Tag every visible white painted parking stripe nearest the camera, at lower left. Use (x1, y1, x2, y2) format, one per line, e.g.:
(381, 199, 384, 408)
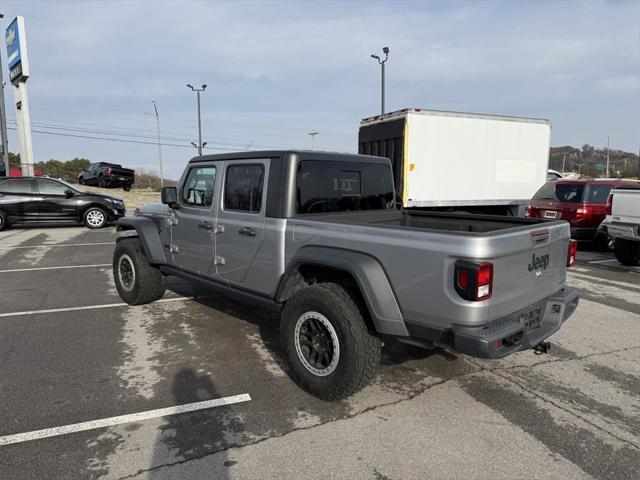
(0, 393, 251, 446)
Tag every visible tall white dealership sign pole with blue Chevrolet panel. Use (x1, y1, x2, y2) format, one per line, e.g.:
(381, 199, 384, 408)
(5, 16, 34, 175)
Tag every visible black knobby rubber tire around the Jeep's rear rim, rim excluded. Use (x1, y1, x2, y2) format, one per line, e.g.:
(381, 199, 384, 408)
(280, 283, 382, 401)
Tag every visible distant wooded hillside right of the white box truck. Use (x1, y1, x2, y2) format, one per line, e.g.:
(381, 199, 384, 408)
(549, 145, 640, 178)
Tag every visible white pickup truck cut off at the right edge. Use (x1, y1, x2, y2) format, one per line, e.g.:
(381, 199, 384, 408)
(603, 184, 640, 266)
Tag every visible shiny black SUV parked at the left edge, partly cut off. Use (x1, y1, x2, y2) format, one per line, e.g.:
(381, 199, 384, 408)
(0, 177, 125, 230)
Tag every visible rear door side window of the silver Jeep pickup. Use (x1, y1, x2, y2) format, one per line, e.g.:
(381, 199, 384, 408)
(224, 165, 264, 213)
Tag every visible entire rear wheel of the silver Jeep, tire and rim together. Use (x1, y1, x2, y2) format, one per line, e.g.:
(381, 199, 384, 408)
(280, 283, 381, 401)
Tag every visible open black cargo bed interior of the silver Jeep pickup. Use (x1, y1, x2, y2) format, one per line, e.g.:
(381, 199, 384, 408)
(299, 210, 550, 235)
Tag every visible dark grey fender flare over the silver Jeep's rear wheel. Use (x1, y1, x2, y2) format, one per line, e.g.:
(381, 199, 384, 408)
(276, 246, 409, 336)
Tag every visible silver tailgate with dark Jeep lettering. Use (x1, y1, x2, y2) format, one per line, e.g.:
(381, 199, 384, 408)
(489, 222, 570, 319)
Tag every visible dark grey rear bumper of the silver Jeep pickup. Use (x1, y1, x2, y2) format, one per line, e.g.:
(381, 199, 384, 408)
(407, 287, 580, 358)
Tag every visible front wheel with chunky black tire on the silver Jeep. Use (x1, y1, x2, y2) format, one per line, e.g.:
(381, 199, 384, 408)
(113, 237, 165, 305)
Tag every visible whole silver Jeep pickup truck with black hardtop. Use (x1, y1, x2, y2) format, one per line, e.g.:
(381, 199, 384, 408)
(113, 151, 579, 400)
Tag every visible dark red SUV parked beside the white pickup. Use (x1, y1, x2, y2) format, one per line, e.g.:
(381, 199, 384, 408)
(527, 179, 631, 248)
